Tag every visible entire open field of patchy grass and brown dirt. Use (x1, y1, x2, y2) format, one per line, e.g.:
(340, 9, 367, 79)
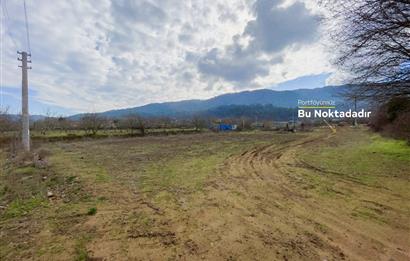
(0, 128, 410, 260)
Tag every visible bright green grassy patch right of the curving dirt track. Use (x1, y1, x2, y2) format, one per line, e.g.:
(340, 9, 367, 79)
(304, 127, 410, 179)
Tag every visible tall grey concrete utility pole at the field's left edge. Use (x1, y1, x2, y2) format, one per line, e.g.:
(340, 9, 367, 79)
(17, 52, 31, 151)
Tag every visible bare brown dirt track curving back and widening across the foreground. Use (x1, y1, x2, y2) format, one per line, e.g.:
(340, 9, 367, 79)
(72, 134, 410, 260)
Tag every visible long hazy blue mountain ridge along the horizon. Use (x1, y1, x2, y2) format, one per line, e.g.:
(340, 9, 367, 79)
(70, 86, 345, 119)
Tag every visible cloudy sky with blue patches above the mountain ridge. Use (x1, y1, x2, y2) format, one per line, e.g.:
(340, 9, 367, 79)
(0, 0, 338, 115)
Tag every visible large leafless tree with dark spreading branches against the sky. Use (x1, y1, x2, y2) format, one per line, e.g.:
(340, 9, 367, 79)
(321, 0, 410, 101)
